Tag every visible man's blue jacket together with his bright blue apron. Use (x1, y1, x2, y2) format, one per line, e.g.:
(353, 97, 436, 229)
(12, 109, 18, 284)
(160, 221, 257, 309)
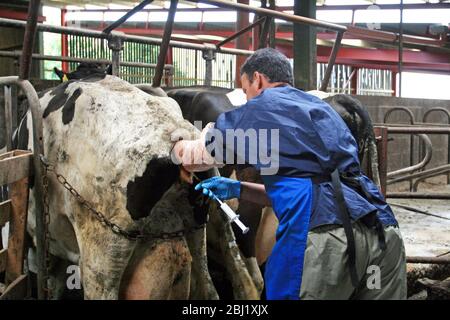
(207, 86, 397, 299)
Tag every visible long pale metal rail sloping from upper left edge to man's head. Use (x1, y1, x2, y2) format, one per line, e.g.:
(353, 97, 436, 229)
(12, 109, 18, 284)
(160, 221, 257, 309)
(0, 18, 253, 55)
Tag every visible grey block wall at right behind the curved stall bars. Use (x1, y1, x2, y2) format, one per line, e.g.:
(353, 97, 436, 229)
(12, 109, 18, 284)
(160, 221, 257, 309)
(356, 96, 450, 182)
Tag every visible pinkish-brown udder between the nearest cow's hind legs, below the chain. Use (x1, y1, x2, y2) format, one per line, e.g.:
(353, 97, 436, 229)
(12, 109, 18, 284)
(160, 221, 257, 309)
(120, 239, 191, 300)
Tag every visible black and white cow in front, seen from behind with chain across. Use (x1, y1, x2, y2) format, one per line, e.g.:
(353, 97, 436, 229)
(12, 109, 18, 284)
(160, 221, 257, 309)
(8, 74, 268, 299)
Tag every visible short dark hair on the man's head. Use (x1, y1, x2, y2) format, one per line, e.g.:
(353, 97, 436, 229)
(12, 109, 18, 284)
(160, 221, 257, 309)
(241, 48, 294, 85)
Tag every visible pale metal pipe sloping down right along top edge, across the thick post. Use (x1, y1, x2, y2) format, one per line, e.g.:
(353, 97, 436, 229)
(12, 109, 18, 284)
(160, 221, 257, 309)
(189, 0, 347, 31)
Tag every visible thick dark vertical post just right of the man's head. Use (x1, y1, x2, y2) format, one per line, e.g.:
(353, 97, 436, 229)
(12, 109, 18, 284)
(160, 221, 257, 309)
(293, 0, 317, 90)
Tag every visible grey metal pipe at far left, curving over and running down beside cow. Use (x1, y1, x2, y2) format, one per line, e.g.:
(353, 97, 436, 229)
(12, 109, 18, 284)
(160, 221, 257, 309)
(0, 76, 48, 300)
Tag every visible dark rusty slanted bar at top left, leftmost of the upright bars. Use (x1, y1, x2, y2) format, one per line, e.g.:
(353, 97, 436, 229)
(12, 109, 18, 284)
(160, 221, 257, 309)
(19, 0, 41, 79)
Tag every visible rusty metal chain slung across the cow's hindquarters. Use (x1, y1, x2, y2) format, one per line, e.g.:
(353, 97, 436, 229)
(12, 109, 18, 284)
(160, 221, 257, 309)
(41, 156, 205, 241)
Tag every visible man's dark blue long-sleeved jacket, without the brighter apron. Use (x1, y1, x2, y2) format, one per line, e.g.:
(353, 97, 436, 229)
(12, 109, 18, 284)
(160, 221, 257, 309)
(213, 86, 398, 230)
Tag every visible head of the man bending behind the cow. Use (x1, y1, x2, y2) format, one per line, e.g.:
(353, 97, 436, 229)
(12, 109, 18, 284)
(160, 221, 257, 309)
(241, 48, 294, 100)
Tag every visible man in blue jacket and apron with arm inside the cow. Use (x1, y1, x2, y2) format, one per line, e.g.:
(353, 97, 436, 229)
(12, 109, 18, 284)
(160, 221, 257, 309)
(174, 49, 406, 299)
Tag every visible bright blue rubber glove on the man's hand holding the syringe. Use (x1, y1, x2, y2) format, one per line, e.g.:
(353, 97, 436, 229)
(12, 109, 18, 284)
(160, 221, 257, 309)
(195, 177, 241, 200)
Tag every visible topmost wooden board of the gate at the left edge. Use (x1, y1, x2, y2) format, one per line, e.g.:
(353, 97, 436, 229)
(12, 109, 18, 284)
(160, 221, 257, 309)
(0, 150, 33, 185)
